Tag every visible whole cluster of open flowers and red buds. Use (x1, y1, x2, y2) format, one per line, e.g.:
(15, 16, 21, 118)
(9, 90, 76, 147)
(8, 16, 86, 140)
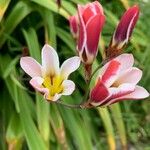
(20, 1, 149, 107)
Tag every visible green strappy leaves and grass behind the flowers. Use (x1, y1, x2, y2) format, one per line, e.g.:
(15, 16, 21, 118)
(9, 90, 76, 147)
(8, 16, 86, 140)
(0, 0, 150, 150)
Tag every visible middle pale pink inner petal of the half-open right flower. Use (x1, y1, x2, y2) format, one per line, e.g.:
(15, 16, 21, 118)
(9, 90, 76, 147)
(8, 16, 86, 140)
(115, 67, 142, 85)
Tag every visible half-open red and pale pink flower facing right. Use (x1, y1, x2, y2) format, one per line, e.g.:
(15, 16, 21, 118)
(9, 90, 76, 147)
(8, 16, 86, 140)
(90, 54, 149, 106)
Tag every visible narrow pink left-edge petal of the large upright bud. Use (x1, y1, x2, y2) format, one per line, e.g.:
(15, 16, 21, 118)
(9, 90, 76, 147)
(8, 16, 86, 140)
(78, 5, 87, 51)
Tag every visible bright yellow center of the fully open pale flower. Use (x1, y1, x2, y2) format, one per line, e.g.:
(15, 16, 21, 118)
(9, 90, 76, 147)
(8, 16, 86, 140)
(43, 76, 63, 100)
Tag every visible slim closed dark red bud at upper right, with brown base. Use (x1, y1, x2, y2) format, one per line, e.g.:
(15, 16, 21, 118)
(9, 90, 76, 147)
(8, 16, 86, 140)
(106, 5, 139, 58)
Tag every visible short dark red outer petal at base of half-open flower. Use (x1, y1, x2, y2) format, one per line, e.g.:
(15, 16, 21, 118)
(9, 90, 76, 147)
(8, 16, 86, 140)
(90, 78, 109, 106)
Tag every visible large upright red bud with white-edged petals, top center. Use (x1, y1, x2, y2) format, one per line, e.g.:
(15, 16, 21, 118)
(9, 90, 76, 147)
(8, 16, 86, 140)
(77, 1, 105, 65)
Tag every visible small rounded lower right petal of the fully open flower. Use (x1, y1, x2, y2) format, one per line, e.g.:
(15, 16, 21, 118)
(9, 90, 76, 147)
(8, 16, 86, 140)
(62, 80, 75, 95)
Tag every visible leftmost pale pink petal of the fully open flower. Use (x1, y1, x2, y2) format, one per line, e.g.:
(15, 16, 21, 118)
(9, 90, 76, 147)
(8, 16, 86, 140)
(20, 57, 42, 77)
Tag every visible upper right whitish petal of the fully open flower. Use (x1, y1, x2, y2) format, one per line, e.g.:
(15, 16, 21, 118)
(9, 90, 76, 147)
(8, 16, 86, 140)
(60, 56, 80, 79)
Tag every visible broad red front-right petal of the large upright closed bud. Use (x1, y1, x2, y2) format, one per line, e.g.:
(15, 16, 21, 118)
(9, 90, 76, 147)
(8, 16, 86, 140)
(86, 14, 105, 55)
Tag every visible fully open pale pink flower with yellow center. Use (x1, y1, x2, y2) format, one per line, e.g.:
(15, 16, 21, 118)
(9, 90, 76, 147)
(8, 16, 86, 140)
(20, 44, 80, 101)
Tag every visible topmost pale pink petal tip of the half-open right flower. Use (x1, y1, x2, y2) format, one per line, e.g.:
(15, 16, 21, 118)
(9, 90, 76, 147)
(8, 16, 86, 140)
(114, 54, 134, 72)
